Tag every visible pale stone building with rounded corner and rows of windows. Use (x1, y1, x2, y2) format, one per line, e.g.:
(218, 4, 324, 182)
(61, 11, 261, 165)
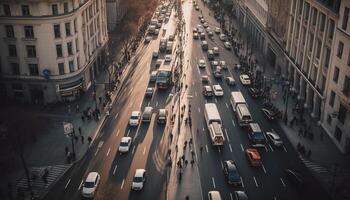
(0, 0, 108, 103)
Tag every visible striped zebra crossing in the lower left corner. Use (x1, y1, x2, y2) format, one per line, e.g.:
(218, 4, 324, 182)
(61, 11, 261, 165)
(16, 164, 71, 197)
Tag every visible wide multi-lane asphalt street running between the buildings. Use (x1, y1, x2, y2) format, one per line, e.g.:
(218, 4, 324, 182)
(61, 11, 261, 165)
(45, 0, 329, 200)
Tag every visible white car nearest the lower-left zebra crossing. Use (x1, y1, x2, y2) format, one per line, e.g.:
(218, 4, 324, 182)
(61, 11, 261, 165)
(81, 172, 101, 198)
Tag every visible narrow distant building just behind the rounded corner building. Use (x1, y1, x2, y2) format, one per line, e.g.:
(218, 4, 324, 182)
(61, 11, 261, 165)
(106, 0, 127, 31)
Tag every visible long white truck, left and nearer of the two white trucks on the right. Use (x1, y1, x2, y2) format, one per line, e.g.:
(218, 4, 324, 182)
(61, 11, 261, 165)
(204, 103, 225, 146)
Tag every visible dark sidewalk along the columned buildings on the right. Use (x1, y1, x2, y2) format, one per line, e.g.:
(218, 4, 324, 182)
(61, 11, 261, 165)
(224, 8, 350, 200)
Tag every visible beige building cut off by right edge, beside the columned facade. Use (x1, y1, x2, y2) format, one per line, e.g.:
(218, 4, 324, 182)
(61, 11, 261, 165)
(322, 1, 350, 153)
